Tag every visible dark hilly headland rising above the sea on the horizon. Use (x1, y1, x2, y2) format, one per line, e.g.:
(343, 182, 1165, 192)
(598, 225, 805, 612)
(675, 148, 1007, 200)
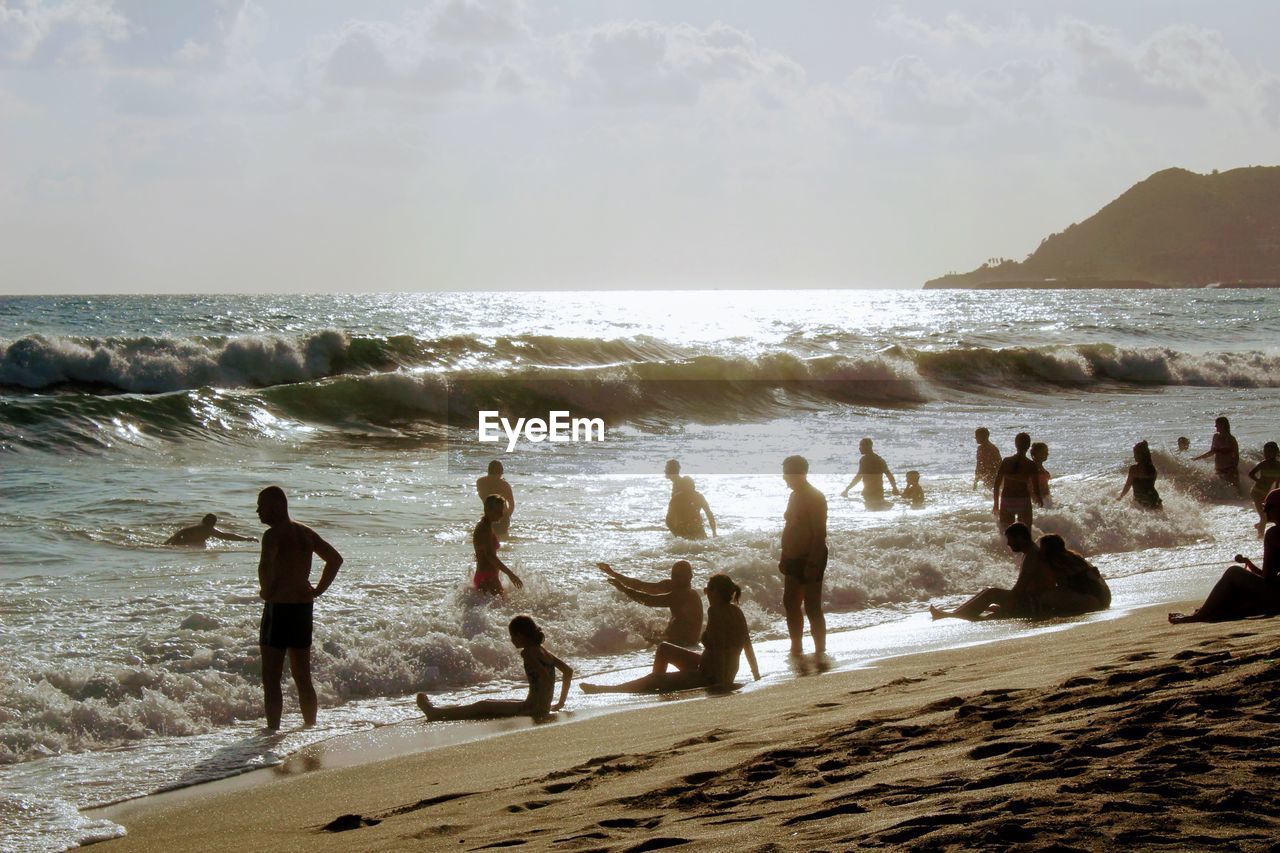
(924, 167, 1280, 289)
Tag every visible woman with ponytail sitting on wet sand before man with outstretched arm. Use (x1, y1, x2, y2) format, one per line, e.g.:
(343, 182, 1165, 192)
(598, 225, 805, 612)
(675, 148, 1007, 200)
(581, 574, 760, 693)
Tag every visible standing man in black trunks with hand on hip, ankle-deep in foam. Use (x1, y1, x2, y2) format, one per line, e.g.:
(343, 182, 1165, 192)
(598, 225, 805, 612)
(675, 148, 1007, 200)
(257, 485, 342, 731)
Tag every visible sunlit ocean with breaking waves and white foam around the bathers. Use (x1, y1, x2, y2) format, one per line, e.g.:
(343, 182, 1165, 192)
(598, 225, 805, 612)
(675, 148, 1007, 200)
(0, 289, 1280, 850)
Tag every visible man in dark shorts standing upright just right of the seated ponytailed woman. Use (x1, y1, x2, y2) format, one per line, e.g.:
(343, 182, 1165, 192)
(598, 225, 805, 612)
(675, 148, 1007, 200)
(778, 456, 827, 656)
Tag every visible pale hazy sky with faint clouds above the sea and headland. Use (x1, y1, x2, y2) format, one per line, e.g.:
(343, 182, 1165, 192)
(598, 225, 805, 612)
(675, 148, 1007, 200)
(0, 0, 1280, 295)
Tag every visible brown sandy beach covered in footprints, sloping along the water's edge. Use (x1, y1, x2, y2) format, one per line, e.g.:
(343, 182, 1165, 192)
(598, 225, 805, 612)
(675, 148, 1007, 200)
(102, 606, 1280, 852)
